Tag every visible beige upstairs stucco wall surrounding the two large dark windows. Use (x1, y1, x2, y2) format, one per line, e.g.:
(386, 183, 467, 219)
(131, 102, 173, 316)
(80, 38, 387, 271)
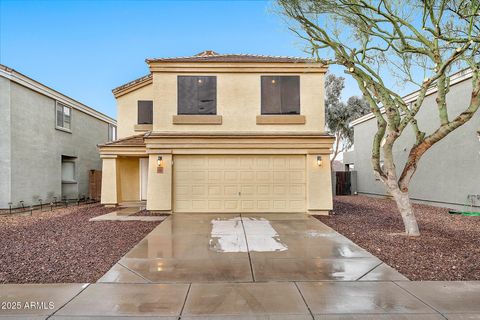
(153, 72, 325, 131)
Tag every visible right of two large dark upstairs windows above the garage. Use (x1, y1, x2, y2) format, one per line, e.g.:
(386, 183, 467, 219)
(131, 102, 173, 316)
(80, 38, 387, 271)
(262, 76, 300, 114)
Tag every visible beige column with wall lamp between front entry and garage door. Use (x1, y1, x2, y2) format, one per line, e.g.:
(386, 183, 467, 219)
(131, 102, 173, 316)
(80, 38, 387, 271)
(147, 153, 172, 211)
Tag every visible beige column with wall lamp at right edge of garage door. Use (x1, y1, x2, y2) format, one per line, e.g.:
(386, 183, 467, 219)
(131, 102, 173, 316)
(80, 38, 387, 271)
(307, 154, 333, 214)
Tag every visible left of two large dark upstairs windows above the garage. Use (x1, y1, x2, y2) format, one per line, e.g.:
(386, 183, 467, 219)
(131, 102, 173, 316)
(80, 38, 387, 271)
(177, 76, 217, 114)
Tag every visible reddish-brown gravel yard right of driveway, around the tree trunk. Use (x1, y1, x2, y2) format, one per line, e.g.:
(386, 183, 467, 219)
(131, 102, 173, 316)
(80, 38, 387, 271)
(317, 196, 480, 280)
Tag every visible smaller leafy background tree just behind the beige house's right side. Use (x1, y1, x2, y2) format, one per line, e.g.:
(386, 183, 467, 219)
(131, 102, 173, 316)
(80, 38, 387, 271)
(325, 74, 370, 165)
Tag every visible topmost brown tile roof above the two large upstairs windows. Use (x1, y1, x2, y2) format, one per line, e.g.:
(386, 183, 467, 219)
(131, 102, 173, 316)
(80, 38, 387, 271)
(146, 50, 317, 63)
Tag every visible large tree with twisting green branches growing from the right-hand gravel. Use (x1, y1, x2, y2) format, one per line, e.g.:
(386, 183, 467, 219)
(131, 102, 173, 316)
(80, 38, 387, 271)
(278, 0, 480, 236)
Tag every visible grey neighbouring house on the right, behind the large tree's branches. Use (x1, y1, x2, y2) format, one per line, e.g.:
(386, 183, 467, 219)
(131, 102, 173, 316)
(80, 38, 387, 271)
(343, 70, 480, 209)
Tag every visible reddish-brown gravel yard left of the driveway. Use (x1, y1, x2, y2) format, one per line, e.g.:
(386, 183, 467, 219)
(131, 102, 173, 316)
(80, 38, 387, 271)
(0, 204, 159, 283)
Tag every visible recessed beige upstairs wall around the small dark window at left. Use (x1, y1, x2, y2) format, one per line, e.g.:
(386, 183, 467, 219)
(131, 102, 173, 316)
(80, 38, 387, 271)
(117, 84, 153, 139)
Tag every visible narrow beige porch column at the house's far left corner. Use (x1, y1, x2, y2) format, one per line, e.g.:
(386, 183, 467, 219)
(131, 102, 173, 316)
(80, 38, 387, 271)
(101, 155, 118, 206)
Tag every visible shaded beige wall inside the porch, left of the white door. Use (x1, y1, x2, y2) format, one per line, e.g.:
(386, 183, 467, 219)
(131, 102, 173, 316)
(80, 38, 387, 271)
(117, 157, 140, 202)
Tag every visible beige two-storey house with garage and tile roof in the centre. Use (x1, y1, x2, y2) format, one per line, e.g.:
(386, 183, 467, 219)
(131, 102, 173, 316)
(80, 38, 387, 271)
(100, 51, 333, 213)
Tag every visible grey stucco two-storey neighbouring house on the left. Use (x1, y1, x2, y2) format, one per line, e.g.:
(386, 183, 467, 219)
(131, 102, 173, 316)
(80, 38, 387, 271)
(0, 65, 116, 208)
